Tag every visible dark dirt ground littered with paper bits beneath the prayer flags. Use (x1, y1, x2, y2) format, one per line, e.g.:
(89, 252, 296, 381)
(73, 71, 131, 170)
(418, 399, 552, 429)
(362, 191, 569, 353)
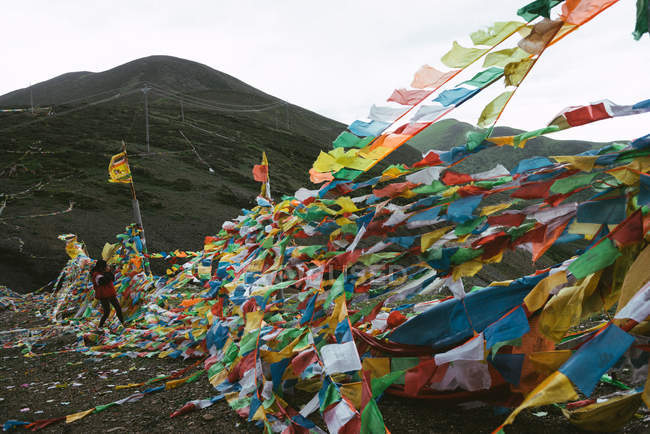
(0, 300, 650, 434)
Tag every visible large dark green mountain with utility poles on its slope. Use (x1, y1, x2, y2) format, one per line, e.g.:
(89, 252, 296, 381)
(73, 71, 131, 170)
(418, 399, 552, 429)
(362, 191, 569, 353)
(0, 56, 419, 290)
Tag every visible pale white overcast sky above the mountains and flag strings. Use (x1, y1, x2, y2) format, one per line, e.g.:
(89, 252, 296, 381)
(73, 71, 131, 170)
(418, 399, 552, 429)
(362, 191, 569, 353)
(0, 0, 650, 141)
